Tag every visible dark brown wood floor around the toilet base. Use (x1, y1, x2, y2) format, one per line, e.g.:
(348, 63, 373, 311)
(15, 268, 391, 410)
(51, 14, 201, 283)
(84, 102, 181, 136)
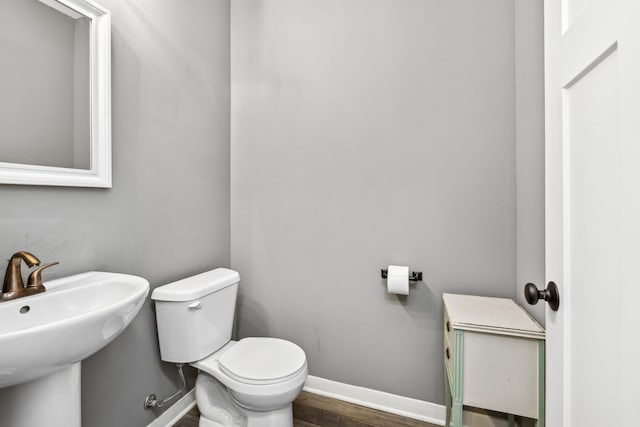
(174, 391, 436, 427)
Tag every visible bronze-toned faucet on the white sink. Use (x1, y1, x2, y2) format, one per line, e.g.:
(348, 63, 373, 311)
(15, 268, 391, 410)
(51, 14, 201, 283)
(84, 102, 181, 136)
(0, 251, 58, 302)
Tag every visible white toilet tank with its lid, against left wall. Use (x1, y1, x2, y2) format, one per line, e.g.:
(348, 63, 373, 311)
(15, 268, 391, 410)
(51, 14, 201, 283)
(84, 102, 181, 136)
(151, 268, 240, 363)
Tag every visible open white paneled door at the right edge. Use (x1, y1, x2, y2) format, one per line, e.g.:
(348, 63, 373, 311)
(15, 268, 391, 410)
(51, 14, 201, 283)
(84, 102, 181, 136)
(545, 0, 640, 427)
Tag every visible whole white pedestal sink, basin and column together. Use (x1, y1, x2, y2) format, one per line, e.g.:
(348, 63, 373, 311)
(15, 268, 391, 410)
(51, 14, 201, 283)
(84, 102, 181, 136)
(0, 272, 149, 427)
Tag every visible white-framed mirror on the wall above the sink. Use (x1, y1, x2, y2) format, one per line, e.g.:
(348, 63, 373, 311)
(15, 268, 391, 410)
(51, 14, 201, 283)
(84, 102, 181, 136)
(0, 0, 111, 187)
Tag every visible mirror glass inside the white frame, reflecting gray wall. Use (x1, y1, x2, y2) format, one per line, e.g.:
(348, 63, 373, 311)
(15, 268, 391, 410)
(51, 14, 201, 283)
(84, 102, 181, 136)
(0, 0, 91, 169)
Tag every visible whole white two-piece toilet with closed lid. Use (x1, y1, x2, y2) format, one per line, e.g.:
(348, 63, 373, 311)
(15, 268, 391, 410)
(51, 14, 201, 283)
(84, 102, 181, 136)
(151, 268, 307, 427)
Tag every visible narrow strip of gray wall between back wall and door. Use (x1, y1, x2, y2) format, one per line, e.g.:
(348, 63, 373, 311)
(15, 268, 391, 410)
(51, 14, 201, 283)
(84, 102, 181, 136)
(514, 0, 546, 325)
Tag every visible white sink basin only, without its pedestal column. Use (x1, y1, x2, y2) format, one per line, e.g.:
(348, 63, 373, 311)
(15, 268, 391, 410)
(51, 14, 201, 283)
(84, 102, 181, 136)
(0, 271, 149, 388)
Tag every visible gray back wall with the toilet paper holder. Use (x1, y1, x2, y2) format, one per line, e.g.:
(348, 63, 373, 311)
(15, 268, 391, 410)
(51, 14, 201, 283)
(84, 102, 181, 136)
(231, 0, 516, 403)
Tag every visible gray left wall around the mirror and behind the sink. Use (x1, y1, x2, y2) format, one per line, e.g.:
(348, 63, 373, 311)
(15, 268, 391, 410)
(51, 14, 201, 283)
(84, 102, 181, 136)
(0, 0, 229, 427)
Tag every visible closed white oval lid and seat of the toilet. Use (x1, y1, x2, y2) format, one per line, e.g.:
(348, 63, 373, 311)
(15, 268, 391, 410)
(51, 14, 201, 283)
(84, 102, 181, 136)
(218, 338, 307, 383)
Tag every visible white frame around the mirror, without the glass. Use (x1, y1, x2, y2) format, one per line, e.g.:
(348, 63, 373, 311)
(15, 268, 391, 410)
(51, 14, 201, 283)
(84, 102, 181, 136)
(0, 0, 111, 188)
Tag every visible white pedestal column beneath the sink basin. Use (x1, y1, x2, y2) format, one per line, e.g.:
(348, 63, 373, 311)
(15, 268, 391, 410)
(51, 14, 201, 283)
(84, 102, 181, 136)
(0, 362, 81, 427)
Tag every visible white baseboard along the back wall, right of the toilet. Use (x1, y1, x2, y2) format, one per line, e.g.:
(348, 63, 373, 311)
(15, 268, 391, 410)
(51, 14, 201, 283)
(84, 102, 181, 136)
(304, 375, 508, 427)
